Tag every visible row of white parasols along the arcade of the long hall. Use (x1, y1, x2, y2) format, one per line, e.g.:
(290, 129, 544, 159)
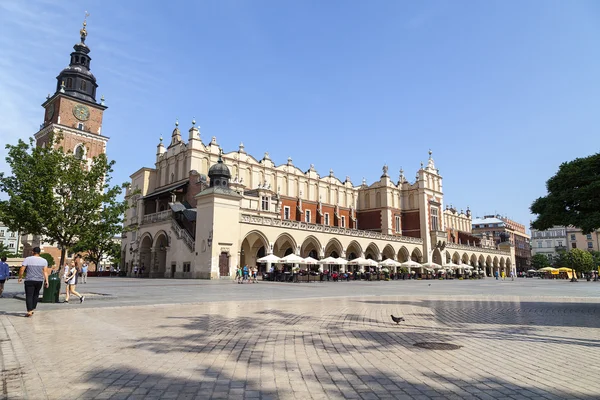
(257, 254, 474, 271)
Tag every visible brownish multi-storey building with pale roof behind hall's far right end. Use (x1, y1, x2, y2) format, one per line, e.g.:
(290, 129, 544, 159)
(473, 215, 531, 272)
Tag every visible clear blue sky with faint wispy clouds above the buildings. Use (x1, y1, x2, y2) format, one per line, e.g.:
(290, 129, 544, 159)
(0, 0, 600, 230)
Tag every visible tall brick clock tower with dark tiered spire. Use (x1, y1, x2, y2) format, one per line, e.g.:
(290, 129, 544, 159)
(34, 16, 108, 159)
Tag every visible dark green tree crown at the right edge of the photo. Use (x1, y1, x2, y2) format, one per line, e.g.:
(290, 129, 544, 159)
(531, 153, 600, 233)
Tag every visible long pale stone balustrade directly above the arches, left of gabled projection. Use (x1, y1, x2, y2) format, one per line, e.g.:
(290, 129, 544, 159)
(240, 214, 423, 244)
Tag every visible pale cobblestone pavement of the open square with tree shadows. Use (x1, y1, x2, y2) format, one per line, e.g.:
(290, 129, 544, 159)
(0, 282, 600, 399)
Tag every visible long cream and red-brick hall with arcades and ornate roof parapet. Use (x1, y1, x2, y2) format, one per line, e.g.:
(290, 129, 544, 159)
(121, 121, 515, 279)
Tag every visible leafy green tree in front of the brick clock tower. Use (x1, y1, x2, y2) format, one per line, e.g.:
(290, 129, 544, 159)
(0, 137, 125, 265)
